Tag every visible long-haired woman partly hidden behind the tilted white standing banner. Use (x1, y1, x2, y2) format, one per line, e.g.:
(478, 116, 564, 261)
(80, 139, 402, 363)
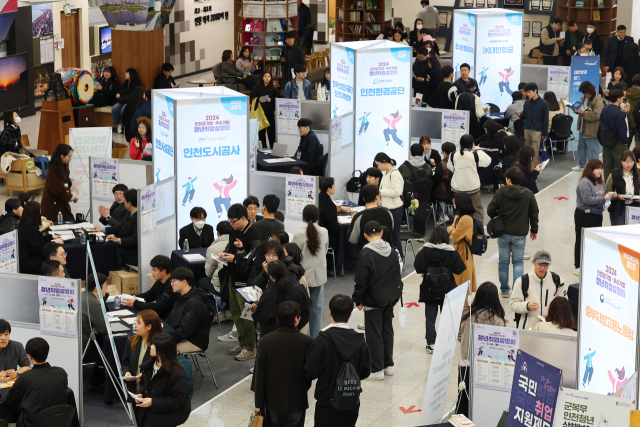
(456, 282, 507, 416)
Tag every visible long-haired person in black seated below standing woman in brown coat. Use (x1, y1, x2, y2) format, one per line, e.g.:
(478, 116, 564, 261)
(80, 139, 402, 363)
(18, 202, 64, 275)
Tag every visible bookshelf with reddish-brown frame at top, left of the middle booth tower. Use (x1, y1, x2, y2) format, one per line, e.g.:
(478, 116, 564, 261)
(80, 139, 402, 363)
(234, 0, 298, 87)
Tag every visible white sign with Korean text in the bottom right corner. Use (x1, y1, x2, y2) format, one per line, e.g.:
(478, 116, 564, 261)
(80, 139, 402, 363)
(553, 387, 635, 427)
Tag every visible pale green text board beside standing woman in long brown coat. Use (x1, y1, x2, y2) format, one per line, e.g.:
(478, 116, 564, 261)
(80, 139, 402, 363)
(69, 127, 113, 221)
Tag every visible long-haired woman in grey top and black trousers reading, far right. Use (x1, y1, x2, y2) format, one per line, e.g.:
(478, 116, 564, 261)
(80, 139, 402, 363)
(573, 159, 617, 276)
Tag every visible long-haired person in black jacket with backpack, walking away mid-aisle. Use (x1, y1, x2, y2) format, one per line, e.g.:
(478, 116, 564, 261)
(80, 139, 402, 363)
(413, 227, 467, 354)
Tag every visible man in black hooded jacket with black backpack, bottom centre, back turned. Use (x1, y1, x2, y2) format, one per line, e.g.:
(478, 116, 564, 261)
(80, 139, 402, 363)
(304, 294, 371, 427)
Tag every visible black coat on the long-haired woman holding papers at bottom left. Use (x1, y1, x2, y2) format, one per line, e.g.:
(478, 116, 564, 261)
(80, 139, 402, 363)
(136, 358, 191, 427)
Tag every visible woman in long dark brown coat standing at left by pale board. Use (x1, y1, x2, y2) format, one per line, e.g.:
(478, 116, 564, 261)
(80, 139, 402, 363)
(42, 144, 78, 221)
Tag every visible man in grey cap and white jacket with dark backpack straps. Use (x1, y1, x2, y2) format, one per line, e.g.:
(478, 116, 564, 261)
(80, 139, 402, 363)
(509, 250, 569, 329)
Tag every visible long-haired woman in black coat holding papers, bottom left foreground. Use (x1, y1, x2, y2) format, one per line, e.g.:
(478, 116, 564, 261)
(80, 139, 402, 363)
(136, 332, 191, 427)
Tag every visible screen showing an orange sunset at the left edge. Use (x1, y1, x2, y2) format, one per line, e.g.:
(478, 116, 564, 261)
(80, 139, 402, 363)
(0, 53, 29, 111)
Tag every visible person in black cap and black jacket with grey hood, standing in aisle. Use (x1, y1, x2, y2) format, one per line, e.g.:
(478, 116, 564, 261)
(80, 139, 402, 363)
(352, 221, 402, 381)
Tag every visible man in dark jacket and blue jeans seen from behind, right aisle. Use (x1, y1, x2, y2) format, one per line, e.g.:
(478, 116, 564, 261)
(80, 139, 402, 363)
(487, 168, 539, 298)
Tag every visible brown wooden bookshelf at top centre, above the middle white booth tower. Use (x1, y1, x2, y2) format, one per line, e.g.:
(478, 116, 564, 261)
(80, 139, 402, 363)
(336, 0, 384, 42)
